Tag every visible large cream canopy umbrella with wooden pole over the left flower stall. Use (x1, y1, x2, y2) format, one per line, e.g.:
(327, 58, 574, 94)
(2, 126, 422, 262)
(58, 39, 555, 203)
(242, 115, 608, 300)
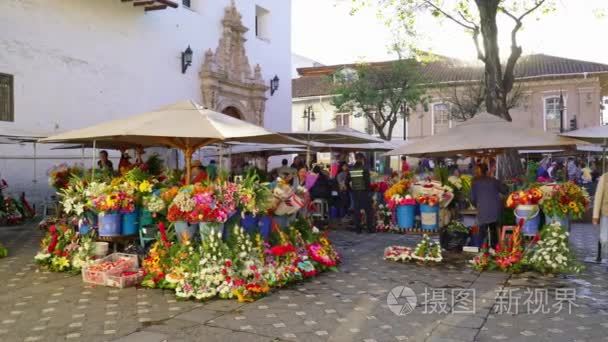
(40, 100, 293, 181)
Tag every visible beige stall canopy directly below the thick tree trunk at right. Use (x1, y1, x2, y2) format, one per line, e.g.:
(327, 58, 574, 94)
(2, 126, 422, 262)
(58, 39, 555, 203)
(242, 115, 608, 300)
(387, 113, 587, 157)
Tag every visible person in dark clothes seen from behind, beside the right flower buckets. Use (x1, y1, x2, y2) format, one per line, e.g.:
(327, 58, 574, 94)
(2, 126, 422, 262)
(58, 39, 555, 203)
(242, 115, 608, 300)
(471, 164, 508, 247)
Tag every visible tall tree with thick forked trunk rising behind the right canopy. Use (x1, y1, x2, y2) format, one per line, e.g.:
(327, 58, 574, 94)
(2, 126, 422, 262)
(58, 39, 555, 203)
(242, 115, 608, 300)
(352, 0, 555, 176)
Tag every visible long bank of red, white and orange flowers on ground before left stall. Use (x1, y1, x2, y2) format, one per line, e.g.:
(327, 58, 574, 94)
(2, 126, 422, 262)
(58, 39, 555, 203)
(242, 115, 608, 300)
(142, 220, 340, 302)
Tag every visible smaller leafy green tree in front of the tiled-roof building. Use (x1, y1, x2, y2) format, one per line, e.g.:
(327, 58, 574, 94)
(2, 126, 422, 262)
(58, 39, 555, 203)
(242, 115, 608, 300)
(331, 60, 424, 140)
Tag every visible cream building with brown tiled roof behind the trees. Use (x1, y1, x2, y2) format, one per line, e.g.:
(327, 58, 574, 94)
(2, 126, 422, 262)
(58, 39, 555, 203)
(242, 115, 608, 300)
(292, 54, 608, 140)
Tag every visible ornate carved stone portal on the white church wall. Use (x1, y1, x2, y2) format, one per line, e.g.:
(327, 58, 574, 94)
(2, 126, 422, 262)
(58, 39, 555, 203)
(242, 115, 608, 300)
(200, 0, 268, 126)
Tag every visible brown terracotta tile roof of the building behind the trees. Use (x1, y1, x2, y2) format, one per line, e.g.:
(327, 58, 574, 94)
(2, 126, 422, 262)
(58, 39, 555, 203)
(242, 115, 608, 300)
(292, 54, 608, 97)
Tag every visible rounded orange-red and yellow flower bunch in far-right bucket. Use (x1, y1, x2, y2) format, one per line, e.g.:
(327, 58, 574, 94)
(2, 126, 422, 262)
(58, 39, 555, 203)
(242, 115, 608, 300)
(540, 182, 589, 219)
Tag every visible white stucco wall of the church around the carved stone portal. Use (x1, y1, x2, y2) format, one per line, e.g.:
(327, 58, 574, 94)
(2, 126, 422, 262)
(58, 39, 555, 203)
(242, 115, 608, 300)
(0, 0, 291, 203)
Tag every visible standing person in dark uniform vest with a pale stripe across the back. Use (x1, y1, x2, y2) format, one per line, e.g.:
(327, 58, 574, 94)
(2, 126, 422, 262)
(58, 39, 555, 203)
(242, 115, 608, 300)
(349, 153, 375, 234)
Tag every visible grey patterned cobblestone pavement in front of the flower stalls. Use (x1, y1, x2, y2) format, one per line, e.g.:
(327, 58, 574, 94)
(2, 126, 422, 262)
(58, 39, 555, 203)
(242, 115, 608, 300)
(0, 225, 608, 342)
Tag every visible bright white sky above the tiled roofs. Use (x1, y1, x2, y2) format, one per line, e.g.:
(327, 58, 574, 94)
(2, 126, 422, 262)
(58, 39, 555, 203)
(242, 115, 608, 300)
(292, 0, 608, 65)
